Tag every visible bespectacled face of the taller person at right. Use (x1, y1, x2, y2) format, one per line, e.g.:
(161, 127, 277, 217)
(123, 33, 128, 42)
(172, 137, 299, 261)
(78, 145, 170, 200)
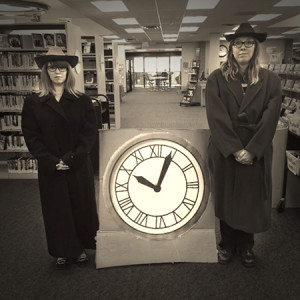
(232, 37, 256, 65)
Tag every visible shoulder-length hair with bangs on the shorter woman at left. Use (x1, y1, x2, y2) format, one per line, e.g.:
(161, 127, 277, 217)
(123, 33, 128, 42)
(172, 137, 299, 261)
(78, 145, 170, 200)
(39, 60, 81, 98)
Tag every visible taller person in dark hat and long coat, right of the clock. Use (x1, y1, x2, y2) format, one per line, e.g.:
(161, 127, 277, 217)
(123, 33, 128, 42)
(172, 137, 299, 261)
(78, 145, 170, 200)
(206, 23, 281, 267)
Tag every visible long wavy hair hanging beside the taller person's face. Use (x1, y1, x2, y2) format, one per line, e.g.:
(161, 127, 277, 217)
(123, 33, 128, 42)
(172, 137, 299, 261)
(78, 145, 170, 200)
(221, 41, 260, 85)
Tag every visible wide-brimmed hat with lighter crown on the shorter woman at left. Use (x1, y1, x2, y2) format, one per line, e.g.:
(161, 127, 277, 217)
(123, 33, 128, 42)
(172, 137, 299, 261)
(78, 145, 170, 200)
(34, 46, 78, 69)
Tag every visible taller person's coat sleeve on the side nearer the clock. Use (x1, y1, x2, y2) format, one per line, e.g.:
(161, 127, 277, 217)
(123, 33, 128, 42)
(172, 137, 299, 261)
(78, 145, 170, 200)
(206, 72, 244, 157)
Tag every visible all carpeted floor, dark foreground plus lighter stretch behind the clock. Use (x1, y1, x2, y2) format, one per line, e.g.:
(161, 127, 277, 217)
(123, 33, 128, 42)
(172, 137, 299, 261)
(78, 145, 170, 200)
(0, 90, 300, 300)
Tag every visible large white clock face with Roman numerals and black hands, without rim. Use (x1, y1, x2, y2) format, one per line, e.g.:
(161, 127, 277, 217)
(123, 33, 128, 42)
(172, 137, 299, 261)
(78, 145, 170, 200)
(109, 138, 205, 235)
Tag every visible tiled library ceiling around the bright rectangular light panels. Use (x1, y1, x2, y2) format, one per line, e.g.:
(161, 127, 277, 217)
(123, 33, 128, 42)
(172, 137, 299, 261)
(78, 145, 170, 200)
(0, 0, 300, 44)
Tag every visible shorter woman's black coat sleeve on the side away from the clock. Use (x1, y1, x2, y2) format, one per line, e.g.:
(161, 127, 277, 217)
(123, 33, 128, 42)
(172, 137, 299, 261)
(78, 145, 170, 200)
(21, 97, 59, 172)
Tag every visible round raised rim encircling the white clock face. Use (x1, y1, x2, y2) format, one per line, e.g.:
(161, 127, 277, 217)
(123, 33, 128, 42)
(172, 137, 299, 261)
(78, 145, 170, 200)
(103, 132, 209, 240)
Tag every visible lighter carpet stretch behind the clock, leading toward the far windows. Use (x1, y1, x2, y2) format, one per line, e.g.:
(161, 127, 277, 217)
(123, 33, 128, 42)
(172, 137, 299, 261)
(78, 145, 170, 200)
(121, 88, 208, 129)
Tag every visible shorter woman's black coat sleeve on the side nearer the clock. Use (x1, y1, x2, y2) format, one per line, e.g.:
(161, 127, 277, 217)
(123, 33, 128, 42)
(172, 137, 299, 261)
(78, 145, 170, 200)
(62, 95, 97, 168)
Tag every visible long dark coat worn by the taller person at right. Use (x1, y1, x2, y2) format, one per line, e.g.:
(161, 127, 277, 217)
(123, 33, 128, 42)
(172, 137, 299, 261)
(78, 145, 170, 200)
(206, 69, 282, 233)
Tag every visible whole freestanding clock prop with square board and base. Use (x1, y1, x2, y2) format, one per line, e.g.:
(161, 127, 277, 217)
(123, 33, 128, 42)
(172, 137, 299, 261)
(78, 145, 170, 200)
(96, 129, 217, 268)
